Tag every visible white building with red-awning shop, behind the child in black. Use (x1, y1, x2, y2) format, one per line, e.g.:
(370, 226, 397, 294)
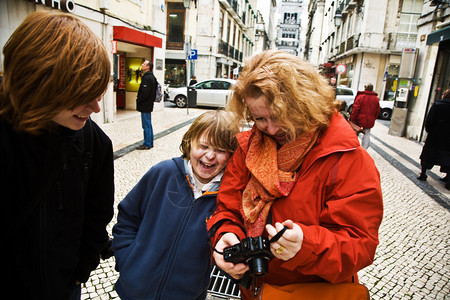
(0, 0, 165, 123)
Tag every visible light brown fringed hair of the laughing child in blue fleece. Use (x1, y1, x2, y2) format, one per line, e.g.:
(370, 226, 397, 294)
(180, 109, 239, 159)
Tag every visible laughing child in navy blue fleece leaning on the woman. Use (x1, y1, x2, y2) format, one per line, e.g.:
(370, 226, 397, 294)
(113, 110, 239, 300)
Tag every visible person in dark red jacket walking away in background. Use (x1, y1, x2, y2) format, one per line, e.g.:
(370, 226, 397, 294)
(350, 83, 381, 150)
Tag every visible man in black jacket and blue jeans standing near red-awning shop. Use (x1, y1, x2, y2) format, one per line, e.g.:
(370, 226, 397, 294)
(136, 60, 156, 150)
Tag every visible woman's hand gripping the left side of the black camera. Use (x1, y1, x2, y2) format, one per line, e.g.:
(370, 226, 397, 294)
(213, 232, 249, 280)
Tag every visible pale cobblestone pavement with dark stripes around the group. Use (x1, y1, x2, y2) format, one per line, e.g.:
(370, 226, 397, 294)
(81, 107, 450, 299)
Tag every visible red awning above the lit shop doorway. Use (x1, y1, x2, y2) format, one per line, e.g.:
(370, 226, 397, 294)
(113, 26, 162, 48)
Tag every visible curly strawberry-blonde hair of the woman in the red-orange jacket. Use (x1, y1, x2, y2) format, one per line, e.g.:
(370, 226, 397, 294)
(228, 50, 335, 140)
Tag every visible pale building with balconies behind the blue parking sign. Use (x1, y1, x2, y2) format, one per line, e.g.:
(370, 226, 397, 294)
(165, 0, 264, 87)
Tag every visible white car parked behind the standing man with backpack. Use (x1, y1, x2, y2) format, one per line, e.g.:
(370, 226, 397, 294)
(167, 78, 236, 107)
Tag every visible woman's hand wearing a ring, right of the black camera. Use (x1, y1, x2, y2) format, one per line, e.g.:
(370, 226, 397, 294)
(266, 220, 303, 261)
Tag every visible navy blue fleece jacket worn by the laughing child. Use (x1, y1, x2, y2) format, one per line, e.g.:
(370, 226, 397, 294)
(112, 157, 219, 300)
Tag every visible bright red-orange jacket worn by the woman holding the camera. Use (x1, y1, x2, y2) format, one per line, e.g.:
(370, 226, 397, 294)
(208, 113, 383, 285)
